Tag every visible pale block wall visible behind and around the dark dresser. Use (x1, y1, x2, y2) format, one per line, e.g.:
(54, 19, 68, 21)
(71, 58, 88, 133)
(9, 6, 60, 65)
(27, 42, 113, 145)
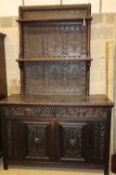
(0, 0, 116, 170)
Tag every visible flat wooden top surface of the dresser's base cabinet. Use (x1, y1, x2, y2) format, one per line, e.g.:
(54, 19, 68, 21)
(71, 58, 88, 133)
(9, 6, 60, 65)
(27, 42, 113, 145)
(0, 94, 113, 107)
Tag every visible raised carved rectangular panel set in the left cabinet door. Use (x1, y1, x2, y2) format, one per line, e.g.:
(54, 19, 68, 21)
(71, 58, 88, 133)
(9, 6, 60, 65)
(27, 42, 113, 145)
(24, 122, 52, 161)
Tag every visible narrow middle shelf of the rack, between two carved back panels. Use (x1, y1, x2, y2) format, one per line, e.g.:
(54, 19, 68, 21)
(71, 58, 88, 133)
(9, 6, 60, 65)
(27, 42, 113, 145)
(16, 56, 92, 62)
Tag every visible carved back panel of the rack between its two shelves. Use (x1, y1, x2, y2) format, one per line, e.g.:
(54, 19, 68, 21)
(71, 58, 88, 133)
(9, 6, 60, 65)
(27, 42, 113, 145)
(23, 21, 87, 59)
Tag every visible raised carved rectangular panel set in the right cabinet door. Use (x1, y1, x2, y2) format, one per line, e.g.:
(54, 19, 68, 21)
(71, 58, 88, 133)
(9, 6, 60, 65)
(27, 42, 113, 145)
(57, 122, 89, 161)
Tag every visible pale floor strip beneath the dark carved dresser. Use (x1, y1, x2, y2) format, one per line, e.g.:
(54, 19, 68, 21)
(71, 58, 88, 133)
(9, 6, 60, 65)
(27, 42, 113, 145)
(0, 160, 115, 175)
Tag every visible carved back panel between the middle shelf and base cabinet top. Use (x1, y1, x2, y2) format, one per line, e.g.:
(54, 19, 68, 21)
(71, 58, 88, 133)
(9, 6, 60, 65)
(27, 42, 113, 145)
(25, 61, 86, 95)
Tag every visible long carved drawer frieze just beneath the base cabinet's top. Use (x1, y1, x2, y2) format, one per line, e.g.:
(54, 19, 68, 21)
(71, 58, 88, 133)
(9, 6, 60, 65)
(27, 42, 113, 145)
(3, 106, 107, 119)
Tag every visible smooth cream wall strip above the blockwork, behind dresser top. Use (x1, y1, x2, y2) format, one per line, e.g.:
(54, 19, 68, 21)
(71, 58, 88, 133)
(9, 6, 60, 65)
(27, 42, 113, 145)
(0, 0, 116, 16)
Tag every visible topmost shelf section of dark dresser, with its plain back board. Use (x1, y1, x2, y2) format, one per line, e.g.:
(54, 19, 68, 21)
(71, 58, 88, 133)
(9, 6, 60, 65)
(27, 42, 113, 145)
(17, 3, 92, 22)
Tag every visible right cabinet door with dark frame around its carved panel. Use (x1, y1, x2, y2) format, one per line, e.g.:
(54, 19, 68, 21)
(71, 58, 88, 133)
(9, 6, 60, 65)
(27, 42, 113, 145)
(56, 122, 90, 162)
